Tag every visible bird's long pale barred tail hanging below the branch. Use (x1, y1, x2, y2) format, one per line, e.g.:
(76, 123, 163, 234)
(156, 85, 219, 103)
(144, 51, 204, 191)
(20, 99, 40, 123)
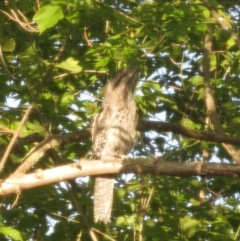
(93, 176, 114, 223)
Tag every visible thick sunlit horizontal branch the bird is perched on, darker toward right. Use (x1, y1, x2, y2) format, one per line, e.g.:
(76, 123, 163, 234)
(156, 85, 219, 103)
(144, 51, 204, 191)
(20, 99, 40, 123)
(0, 158, 240, 195)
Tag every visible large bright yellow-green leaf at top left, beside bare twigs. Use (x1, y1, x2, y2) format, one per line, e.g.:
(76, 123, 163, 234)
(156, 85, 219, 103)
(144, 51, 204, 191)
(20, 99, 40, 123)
(33, 5, 64, 33)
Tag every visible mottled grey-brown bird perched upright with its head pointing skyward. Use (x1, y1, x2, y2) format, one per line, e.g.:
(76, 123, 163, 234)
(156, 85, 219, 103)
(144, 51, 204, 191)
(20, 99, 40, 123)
(92, 67, 138, 223)
